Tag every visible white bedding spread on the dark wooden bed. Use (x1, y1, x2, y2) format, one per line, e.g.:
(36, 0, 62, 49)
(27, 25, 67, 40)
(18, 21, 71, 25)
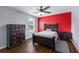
(35, 31, 58, 41)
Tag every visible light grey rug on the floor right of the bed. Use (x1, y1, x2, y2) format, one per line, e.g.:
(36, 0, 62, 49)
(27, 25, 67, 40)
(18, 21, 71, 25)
(55, 40, 70, 53)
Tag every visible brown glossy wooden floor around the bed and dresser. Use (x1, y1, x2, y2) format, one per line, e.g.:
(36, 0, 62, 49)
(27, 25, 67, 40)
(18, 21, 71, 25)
(0, 39, 78, 53)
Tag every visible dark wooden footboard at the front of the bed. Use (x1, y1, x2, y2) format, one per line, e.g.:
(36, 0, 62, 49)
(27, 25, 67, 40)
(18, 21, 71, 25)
(33, 34, 55, 50)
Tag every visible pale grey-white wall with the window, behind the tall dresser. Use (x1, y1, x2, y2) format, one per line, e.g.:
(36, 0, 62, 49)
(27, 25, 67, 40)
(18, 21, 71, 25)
(0, 7, 37, 48)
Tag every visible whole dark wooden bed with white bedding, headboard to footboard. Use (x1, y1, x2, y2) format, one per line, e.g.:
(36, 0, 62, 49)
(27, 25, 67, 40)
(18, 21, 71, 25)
(33, 24, 58, 50)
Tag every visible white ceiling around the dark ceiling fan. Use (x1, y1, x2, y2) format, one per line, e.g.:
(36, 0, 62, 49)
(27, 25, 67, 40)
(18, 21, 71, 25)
(10, 6, 71, 17)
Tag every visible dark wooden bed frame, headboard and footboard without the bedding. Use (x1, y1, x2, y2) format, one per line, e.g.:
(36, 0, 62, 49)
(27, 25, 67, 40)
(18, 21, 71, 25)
(33, 24, 58, 50)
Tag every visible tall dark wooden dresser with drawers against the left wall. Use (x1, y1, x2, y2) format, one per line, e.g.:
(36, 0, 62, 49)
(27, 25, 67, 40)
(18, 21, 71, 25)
(7, 24, 25, 48)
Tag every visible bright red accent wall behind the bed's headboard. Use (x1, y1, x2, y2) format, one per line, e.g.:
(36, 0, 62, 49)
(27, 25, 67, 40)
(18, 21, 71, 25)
(38, 12, 71, 32)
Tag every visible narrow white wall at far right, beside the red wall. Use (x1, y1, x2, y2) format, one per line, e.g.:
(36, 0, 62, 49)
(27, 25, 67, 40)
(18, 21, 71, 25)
(72, 7, 79, 52)
